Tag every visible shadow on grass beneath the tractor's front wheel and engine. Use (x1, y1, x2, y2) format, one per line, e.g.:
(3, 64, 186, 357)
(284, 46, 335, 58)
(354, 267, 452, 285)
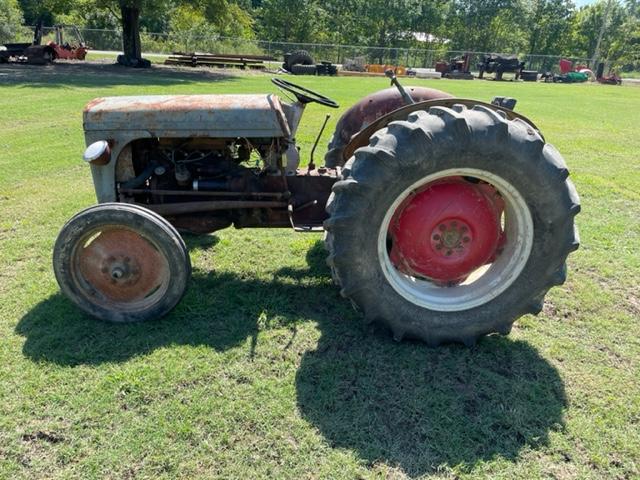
(16, 235, 330, 366)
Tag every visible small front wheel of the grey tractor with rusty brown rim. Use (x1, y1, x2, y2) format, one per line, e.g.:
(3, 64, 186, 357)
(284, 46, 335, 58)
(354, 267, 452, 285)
(53, 203, 191, 322)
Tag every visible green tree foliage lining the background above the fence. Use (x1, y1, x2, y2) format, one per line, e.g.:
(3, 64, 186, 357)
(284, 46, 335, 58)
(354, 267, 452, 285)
(7, 0, 640, 68)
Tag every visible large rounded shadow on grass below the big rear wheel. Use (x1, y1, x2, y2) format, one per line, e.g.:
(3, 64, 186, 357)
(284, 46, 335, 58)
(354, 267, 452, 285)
(297, 331, 566, 477)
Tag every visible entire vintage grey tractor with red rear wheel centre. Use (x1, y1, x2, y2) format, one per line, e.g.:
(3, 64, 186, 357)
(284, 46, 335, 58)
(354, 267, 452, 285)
(53, 74, 580, 345)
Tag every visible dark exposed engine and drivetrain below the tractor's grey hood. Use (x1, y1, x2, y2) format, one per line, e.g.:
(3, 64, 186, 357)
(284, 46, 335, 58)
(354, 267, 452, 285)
(116, 138, 337, 233)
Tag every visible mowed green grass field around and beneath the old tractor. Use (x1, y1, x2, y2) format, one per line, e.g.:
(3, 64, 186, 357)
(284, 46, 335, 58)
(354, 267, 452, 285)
(0, 64, 640, 479)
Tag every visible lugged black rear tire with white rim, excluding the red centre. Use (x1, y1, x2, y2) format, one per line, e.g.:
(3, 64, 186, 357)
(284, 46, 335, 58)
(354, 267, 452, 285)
(325, 105, 580, 346)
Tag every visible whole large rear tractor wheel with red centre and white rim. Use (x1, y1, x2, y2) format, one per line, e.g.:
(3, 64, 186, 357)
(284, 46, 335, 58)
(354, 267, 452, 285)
(325, 105, 580, 346)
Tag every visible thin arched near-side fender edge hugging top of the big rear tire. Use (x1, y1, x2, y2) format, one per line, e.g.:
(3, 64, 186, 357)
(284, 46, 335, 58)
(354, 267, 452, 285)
(340, 97, 544, 161)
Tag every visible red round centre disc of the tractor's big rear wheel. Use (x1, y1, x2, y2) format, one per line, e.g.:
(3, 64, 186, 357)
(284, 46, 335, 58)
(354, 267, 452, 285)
(389, 177, 502, 284)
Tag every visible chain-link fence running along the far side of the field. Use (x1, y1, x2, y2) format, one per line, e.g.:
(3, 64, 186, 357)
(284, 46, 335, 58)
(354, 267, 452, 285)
(10, 27, 595, 72)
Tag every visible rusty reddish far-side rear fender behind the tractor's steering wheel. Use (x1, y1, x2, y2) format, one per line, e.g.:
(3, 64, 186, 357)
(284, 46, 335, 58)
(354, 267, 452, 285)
(324, 87, 452, 167)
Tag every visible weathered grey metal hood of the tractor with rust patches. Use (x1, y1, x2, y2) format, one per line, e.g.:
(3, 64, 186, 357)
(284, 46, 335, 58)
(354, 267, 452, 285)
(83, 95, 290, 138)
